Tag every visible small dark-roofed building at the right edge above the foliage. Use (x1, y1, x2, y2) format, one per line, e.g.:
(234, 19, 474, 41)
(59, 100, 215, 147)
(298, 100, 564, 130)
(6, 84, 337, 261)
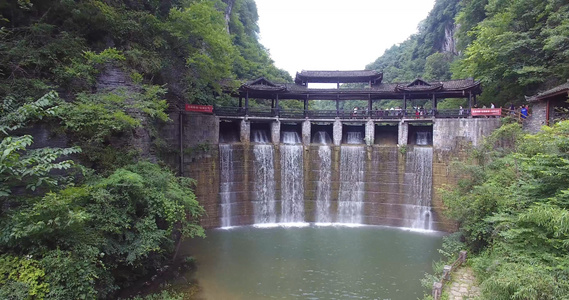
(524, 80, 569, 133)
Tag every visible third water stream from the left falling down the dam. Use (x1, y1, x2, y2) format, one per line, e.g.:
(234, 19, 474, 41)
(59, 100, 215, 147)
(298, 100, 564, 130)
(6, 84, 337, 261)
(280, 132, 304, 223)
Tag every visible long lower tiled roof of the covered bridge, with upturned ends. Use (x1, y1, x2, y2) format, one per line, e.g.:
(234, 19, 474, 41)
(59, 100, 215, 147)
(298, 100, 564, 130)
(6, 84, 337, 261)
(239, 78, 482, 100)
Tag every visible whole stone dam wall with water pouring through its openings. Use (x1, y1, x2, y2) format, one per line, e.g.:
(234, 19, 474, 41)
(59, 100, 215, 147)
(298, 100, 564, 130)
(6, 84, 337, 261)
(162, 112, 500, 231)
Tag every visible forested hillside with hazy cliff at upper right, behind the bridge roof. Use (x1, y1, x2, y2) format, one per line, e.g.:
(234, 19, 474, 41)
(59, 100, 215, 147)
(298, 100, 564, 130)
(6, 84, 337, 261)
(366, 0, 569, 105)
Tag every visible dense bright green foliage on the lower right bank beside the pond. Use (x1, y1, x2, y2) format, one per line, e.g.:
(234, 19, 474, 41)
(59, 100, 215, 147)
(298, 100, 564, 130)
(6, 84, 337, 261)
(443, 121, 569, 300)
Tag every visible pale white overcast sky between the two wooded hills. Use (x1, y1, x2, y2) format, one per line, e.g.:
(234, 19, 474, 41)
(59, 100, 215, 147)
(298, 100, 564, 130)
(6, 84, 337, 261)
(256, 0, 435, 78)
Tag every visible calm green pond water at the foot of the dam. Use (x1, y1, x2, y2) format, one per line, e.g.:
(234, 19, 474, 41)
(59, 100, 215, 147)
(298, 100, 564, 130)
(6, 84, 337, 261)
(184, 225, 443, 300)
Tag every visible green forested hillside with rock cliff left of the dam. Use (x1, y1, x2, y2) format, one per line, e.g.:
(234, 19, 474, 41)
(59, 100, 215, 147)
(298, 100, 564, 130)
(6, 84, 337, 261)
(0, 0, 291, 299)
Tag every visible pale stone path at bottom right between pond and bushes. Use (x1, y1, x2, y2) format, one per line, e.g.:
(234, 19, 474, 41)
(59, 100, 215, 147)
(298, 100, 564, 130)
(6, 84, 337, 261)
(445, 266, 480, 300)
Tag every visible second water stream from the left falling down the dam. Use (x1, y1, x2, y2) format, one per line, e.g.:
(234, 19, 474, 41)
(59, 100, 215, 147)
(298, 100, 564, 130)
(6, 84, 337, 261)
(253, 144, 277, 224)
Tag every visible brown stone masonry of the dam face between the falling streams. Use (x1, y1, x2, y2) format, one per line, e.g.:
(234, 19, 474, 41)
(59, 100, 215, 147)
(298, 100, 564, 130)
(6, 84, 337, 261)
(162, 114, 500, 231)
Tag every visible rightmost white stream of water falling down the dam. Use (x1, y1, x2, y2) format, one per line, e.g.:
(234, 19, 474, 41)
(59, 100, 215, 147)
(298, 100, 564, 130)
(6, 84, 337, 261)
(404, 147, 433, 230)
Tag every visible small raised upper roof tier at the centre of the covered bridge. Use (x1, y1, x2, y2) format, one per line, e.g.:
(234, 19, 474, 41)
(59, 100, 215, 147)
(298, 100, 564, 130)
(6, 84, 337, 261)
(294, 70, 383, 84)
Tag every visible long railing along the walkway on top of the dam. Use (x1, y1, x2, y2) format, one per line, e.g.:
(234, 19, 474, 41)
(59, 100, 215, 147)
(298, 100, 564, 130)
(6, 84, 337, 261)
(213, 107, 499, 120)
